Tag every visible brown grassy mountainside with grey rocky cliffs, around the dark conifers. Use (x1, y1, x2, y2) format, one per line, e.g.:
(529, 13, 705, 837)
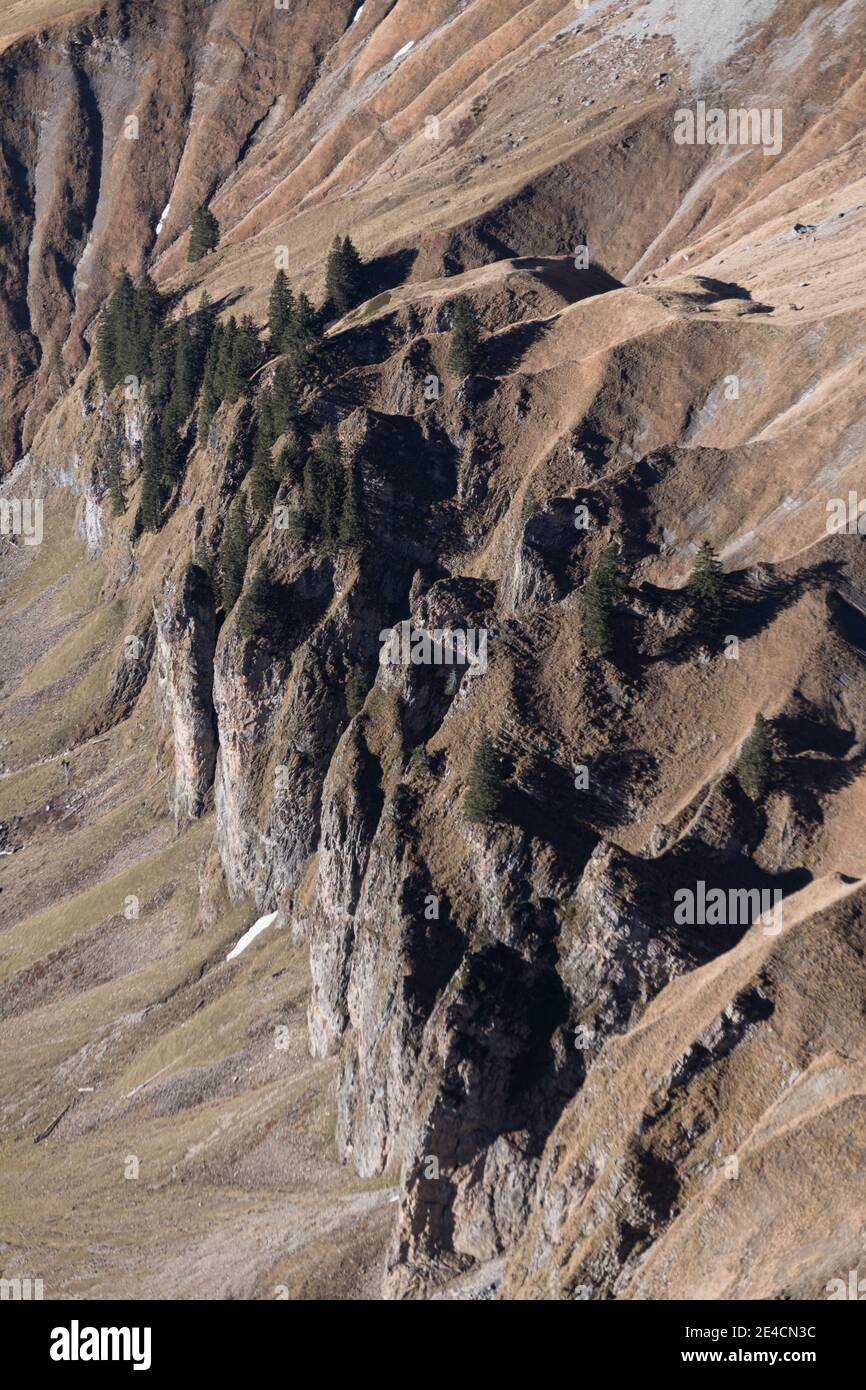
(0, 0, 866, 1298)
